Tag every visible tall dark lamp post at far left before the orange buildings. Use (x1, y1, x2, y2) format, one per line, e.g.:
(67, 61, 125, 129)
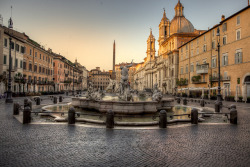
(5, 18, 13, 103)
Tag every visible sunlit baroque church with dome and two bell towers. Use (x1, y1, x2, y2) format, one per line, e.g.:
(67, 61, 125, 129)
(134, 1, 204, 94)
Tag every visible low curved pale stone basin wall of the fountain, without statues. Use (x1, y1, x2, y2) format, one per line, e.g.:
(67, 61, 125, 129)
(72, 97, 174, 114)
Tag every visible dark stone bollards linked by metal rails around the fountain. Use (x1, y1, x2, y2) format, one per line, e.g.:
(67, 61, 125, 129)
(13, 99, 237, 128)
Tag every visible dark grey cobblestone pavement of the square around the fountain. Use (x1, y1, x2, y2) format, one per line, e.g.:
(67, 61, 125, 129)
(0, 95, 250, 167)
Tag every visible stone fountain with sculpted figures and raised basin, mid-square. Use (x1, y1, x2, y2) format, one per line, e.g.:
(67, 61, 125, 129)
(72, 63, 174, 114)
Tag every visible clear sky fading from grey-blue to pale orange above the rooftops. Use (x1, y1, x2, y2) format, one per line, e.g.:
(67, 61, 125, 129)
(0, 0, 248, 70)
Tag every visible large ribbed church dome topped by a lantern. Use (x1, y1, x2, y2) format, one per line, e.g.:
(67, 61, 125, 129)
(170, 1, 194, 34)
